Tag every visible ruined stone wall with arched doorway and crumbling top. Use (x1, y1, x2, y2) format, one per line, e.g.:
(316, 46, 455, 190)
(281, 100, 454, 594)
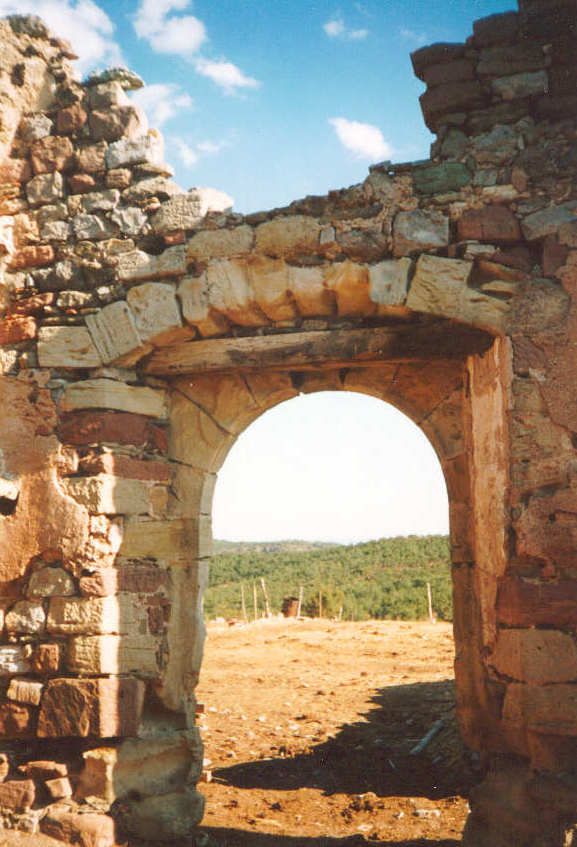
(0, 0, 577, 847)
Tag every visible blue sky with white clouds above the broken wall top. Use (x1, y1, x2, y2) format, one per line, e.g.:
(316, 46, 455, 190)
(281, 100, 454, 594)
(0, 0, 514, 212)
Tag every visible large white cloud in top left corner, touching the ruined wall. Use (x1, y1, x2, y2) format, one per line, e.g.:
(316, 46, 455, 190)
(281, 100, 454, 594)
(0, 0, 122, 73)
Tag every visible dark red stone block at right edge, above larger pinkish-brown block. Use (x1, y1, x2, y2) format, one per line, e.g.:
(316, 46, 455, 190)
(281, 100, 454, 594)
(497, 577, 577, 627)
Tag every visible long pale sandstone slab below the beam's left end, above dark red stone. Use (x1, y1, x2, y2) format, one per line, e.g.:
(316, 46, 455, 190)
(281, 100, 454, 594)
(60, 379, 167, 418)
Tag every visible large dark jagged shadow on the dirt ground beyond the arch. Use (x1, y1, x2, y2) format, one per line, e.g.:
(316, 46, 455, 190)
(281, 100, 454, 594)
(213, 680, 474, 800)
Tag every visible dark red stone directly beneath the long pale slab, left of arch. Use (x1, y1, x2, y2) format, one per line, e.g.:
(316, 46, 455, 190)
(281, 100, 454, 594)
(60, 411, 168, 451)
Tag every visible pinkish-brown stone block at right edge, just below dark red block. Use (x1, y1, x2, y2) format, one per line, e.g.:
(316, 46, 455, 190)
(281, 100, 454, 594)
(489, 629, 577, 685)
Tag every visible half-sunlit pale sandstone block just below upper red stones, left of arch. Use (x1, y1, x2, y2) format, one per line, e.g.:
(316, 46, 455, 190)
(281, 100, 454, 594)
(61, 474, 151, 515)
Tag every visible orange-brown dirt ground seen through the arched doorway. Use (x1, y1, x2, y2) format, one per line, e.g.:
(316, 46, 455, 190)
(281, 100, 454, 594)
(197, 619, 474, 847)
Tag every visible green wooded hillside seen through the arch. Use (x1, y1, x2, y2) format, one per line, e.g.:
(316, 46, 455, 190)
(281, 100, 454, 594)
(205, 535, 452, 620)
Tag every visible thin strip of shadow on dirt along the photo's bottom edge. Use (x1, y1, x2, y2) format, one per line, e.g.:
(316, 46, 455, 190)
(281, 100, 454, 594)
(196, 827, 461, 847)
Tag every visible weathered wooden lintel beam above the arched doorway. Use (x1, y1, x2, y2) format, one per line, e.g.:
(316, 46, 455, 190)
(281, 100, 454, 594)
(145, 324, 492, 376)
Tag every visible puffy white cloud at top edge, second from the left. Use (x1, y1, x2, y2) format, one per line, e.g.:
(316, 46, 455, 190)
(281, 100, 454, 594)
(134, 0, 206, 57)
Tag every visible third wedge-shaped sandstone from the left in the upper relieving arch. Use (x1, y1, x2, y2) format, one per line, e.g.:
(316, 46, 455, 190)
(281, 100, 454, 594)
(126, 282, 182, 344)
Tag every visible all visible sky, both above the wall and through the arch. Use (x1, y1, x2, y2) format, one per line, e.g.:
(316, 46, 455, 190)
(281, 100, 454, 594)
(0, 0, 515, 541)
